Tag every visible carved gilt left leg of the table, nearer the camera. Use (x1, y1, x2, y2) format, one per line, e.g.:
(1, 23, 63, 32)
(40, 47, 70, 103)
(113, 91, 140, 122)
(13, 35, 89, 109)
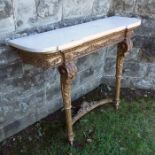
(59, 62, 77, 145)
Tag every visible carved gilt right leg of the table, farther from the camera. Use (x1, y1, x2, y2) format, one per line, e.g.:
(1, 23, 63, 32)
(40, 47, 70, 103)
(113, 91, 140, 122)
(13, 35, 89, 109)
(114, 38, 133, 109)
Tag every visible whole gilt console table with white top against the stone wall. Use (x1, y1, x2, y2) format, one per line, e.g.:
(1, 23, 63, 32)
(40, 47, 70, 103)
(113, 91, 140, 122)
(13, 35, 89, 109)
(8, 16, 141, 144)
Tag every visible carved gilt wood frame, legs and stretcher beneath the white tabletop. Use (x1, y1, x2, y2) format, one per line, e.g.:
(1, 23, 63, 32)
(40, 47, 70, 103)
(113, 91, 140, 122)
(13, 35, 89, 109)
(15, 28, 134, 145)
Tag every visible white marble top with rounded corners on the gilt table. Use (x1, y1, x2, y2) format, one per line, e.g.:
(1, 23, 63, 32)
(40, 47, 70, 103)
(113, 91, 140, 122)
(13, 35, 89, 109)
(8, 16, 141, 53)
